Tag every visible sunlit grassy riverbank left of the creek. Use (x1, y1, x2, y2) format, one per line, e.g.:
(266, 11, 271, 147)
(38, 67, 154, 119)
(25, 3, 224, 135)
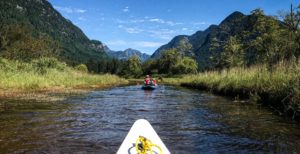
(0, 58, 128, 96)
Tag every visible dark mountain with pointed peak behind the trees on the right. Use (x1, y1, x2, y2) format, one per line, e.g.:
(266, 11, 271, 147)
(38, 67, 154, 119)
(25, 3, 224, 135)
(151, 11, 247, 70)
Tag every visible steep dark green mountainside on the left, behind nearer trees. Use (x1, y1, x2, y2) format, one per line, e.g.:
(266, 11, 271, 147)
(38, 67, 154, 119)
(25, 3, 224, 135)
(0, 0, 107, 65)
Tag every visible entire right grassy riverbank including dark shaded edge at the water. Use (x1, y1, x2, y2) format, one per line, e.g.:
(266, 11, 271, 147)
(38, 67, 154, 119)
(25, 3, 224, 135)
(164, 61, 300, 116)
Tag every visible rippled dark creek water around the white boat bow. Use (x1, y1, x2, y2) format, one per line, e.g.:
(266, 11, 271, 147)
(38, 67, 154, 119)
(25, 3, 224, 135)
(0, 85, 300, 154)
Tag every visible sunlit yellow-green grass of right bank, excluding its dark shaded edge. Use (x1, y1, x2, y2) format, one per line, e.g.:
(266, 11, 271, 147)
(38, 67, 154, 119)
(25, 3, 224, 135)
(164, 61, 300, 109)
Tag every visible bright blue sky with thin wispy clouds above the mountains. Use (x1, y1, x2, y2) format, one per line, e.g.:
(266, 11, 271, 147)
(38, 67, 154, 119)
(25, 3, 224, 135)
(48, 0, 300, 54)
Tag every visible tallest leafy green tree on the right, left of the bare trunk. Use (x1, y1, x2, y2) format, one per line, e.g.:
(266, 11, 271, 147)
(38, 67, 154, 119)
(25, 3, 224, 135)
(247, 9, 285, 64)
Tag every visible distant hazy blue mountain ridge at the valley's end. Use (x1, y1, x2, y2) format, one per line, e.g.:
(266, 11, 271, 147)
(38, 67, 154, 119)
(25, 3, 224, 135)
(104, 45, 150, 62)
